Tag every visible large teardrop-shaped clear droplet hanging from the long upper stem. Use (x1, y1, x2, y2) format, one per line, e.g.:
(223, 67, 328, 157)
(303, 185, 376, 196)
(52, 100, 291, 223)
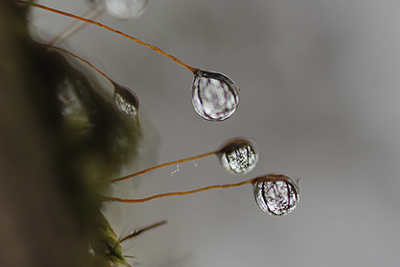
(192, 70, 239, 121)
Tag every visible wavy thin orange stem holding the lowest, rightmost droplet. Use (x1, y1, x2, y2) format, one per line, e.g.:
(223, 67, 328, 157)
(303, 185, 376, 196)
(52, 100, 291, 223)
(105, 178, 255, 203)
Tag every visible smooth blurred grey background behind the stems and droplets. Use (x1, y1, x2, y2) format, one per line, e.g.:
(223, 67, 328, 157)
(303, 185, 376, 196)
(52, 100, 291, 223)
(31, 0, 400, 267)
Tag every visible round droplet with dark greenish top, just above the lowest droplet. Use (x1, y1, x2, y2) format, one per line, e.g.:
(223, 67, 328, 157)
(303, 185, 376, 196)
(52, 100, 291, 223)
(216, 137, 258, 174)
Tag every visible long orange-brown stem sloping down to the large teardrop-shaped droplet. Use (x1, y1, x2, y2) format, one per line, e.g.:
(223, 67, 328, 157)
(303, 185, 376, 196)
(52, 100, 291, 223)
(14, 0, 199, 73)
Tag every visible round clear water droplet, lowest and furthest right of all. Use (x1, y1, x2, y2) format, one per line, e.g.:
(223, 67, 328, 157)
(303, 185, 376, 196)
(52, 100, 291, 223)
(253, 174, 300, 216)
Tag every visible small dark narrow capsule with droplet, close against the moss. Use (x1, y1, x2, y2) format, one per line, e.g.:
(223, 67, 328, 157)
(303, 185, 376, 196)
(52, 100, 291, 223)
(113, 83, 139, 122)
